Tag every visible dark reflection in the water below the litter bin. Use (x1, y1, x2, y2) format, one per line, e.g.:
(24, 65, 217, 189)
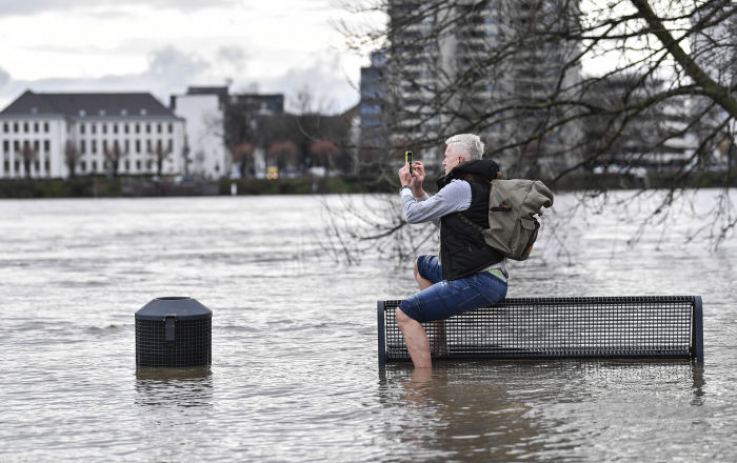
(136, 366, 213, 407)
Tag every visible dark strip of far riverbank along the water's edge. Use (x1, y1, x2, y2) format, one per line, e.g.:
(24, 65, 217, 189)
(0, 172, 737, 199)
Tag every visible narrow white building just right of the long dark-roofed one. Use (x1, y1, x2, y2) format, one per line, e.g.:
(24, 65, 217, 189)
(171, 87, 232, 179)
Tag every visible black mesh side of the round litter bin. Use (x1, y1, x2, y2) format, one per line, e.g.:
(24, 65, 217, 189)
(136, 318, 212, 367)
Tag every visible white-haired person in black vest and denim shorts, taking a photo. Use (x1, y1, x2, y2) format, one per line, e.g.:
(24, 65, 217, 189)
(396, 134, 507, 368)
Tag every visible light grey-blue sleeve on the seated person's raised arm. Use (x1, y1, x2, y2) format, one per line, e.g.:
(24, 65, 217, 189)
(401, 180, 471, 226)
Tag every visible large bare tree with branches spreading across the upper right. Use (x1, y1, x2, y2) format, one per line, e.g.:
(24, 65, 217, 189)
(324, 0, 737, 260)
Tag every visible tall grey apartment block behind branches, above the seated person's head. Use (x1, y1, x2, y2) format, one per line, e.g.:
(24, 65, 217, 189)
(386, 0, 581, 173)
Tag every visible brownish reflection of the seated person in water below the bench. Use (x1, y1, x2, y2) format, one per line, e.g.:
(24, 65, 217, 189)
(386, 363, 539, 461)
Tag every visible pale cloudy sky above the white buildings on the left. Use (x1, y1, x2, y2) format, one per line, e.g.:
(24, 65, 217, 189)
(0, 0, 382, 113)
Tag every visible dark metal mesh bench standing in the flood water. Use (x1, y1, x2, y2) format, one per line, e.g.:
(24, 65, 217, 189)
(378, 296, 704, 367)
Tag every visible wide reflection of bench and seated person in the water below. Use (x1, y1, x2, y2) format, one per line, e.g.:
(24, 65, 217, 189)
(379, 361, 704, 462)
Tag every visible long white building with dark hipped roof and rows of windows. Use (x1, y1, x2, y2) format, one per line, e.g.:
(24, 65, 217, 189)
(0, 90, 184, 178)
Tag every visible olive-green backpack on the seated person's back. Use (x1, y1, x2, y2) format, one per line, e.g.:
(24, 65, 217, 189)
(459, 180, 553, 260)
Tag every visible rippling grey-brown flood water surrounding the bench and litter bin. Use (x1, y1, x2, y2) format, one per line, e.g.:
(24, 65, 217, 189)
(0, 191, 737, 462)
